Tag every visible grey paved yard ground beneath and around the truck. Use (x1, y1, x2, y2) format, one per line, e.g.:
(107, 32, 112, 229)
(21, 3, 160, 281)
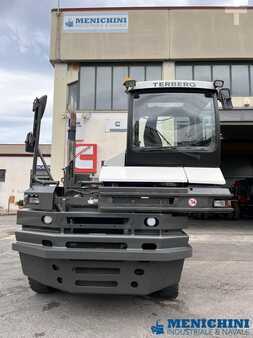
(0, 216, 253, 338)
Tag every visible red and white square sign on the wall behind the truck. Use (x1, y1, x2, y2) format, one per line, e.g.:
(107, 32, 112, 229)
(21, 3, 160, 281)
(74, 143, 97, 174)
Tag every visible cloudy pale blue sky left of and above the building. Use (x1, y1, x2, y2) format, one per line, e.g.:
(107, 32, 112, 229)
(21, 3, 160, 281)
(0, 0, 253, 143)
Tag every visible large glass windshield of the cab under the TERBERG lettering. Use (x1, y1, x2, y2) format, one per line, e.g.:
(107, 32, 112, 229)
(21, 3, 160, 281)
(133, 92, 215, 150)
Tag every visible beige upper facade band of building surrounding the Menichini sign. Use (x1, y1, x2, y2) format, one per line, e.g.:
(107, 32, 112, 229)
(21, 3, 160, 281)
(50, 8, 253, 62)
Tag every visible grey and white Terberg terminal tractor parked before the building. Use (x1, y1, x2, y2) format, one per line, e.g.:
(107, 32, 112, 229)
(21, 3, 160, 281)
(13, 80, 232, 299)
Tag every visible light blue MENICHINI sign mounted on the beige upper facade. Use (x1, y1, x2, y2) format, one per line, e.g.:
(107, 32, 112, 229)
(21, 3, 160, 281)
(63, 13, 128, 33)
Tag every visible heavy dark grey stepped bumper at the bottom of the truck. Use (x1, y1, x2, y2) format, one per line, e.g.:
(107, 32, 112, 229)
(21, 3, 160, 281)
(13, 210, 192, 295)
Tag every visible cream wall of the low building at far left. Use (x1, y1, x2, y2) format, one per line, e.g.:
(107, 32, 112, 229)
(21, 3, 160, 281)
(0, 156, 50, 210)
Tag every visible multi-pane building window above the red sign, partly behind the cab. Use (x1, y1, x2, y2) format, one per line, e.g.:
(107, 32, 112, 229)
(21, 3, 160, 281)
(79, 63, 162, 111)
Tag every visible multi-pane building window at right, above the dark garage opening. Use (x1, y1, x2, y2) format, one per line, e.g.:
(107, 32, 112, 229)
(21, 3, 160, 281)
(176, 62, 253, 96)
